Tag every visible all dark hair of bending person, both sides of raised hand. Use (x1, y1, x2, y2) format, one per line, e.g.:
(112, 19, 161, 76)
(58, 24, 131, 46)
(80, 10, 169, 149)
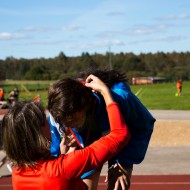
(48, 70, 127, 125)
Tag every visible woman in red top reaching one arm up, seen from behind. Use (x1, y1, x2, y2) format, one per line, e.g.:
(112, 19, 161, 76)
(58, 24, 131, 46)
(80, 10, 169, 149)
(2, 75, 130, 190)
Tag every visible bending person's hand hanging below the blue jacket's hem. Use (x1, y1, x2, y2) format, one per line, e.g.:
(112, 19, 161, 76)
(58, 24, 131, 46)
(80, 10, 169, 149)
(105, 163, 130, 190)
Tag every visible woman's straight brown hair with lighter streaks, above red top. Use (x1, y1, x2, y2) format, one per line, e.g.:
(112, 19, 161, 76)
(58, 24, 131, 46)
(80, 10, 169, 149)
(2, 101, 50, 167)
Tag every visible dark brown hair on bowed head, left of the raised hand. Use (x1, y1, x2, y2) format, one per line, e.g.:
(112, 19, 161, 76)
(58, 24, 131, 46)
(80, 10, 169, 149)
(48, 78, 93, 124)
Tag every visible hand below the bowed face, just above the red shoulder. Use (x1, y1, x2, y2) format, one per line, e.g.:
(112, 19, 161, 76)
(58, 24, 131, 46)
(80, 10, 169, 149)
(60, 134, 77, 154)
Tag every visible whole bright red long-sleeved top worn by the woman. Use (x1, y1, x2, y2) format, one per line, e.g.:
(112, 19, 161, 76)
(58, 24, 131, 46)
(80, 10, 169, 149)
(12, 103, 130, 190)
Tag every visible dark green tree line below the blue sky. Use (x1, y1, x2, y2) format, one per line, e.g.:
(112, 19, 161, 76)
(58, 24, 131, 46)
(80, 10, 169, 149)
(0, 52, 190, 81)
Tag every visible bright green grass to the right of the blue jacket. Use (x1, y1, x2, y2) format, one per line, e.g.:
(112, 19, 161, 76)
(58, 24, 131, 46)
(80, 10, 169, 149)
(131, 82, 190, 110)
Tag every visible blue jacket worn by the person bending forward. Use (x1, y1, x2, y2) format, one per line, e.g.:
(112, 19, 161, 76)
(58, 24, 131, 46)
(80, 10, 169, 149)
(48, 82, 155, 168)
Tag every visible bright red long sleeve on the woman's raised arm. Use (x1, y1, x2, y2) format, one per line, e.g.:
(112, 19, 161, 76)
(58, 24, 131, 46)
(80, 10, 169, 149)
(59, 103, 130, 178)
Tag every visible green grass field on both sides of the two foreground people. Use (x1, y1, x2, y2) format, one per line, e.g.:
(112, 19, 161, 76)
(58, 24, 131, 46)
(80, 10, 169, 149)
(0, 81, 190, 110)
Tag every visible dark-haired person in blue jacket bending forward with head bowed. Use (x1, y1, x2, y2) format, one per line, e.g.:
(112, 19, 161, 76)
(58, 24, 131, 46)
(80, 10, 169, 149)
(48, 70, 155, 190)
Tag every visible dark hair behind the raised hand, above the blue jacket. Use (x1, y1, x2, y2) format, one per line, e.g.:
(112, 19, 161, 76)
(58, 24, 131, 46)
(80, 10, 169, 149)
(76, 69, 127, 87)
